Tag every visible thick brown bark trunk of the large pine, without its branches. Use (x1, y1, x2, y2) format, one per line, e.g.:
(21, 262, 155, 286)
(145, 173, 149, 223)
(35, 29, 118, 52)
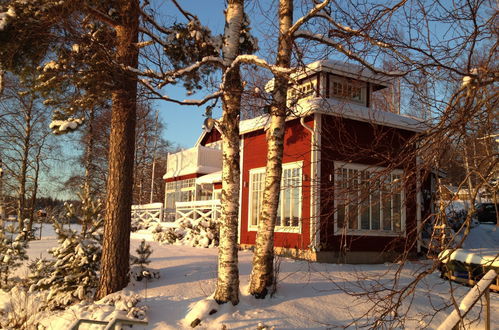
(96, 0, 139, 299)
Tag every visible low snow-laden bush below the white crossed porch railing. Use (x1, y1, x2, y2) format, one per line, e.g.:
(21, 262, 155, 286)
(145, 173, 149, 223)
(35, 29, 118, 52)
(153, 218, 219, 248)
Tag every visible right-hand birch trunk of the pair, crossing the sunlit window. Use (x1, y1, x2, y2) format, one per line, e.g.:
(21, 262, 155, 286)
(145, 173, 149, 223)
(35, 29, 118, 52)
(249, 0, 293, 298)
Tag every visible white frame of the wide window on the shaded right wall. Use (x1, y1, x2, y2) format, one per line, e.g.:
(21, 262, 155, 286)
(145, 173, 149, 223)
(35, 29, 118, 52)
(334, 161, 406, 237)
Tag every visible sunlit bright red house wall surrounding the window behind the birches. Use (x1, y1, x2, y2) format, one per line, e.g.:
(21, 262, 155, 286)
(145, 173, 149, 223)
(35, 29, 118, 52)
(240, 116, 314, 249)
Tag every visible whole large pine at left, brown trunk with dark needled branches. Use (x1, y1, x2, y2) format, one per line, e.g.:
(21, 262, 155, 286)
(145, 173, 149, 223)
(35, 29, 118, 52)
(0, 0, 229, 298)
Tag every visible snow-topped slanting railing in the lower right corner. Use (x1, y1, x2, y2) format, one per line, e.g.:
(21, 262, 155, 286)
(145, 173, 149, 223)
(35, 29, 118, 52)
(438, 269, 497, 330)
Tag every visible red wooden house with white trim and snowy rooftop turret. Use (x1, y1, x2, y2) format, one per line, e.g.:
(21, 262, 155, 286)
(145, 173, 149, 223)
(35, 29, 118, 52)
(164, 61, 423, 263)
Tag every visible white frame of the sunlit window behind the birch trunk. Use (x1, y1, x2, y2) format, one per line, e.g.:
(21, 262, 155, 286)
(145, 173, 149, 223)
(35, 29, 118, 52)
(248, 161, 303, 233)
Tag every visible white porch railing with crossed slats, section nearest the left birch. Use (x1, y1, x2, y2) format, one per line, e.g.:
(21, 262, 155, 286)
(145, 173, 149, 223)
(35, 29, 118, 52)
(175, 199, 221, 221)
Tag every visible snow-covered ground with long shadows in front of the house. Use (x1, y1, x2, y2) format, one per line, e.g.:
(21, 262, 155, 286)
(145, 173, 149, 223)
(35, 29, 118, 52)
(0, 225, 499, 329)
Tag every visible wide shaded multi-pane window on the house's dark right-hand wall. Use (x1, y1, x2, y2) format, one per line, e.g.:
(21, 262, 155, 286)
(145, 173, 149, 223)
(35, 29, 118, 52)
(335, 162, 405, 235)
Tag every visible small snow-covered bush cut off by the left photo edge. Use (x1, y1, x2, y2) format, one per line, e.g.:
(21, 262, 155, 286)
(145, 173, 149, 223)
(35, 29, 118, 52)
(0, 225, 28, 289)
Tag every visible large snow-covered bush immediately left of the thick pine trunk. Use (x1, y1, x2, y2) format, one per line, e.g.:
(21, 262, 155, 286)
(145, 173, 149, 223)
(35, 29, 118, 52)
(30, 187, 103, 309)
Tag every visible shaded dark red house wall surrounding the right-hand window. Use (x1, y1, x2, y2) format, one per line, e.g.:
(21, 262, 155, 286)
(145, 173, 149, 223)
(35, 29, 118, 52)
(320, 115, 416, 251)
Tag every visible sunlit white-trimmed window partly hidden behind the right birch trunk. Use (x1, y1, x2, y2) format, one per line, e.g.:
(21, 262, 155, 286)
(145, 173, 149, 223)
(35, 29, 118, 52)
(249, 162, 302, 231)
